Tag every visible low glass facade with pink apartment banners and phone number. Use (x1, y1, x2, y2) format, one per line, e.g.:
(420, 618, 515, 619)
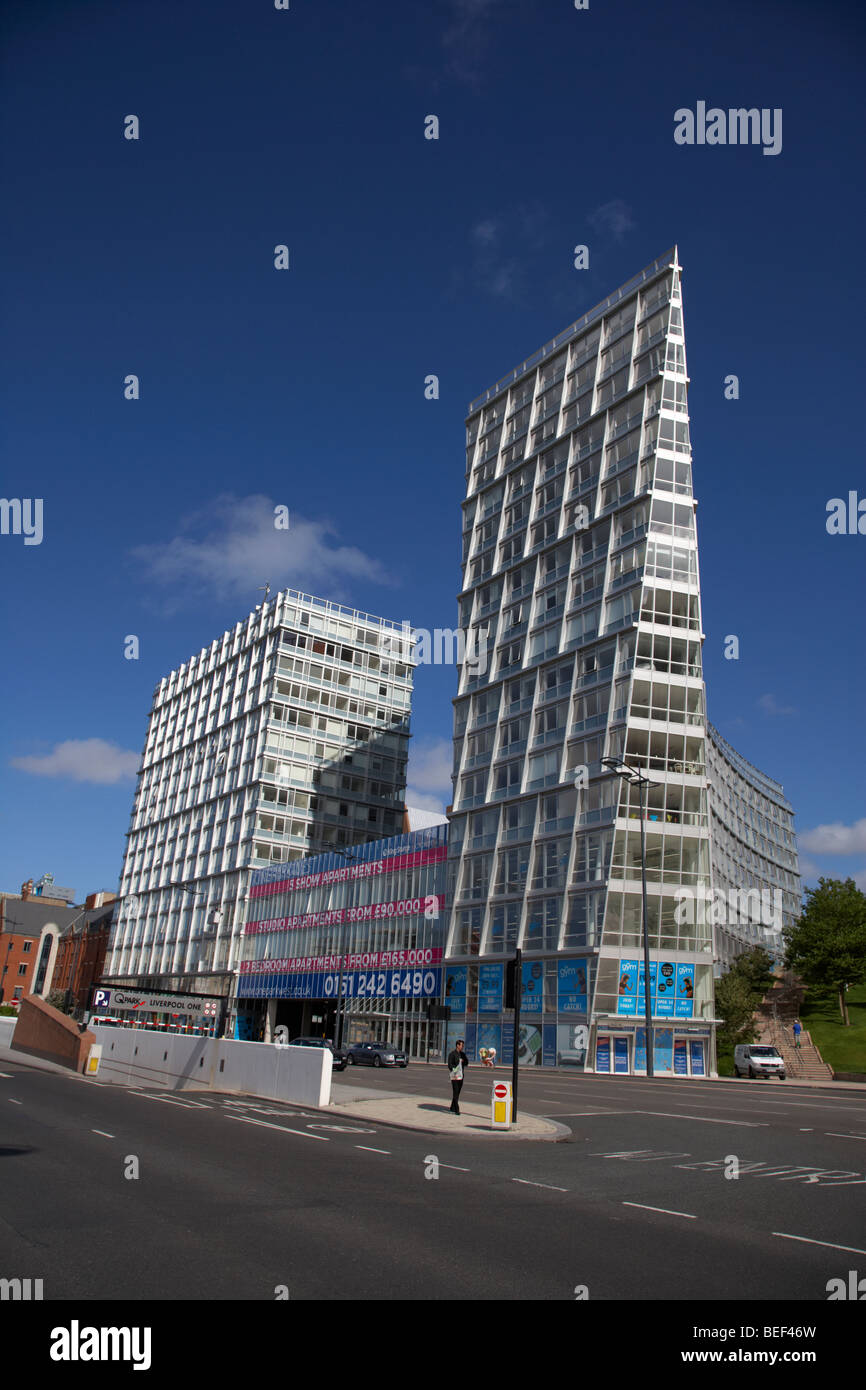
(238, 824, 448, 1058)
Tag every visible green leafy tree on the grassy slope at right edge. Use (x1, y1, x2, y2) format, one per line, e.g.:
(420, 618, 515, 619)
(783, 878, 866, 1027)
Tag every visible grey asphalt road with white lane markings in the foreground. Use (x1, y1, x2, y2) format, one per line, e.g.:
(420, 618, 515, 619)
(0, 1062, 866, 1322)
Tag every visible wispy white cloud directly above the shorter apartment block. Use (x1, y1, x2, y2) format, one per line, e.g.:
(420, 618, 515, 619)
(132, 493, 391, 609)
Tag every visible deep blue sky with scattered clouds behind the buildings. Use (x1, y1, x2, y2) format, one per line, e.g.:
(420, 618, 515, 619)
(0, 0, 866, 899)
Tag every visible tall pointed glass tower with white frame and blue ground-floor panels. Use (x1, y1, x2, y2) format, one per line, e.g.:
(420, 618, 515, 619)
(448, 249, 713, 1074)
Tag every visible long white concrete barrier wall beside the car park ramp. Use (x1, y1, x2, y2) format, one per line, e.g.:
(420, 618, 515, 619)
(90, 1023, 334, 1105)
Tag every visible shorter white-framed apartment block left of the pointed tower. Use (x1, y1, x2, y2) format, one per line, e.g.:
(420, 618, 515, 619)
(104, 589, 413, 1023)
